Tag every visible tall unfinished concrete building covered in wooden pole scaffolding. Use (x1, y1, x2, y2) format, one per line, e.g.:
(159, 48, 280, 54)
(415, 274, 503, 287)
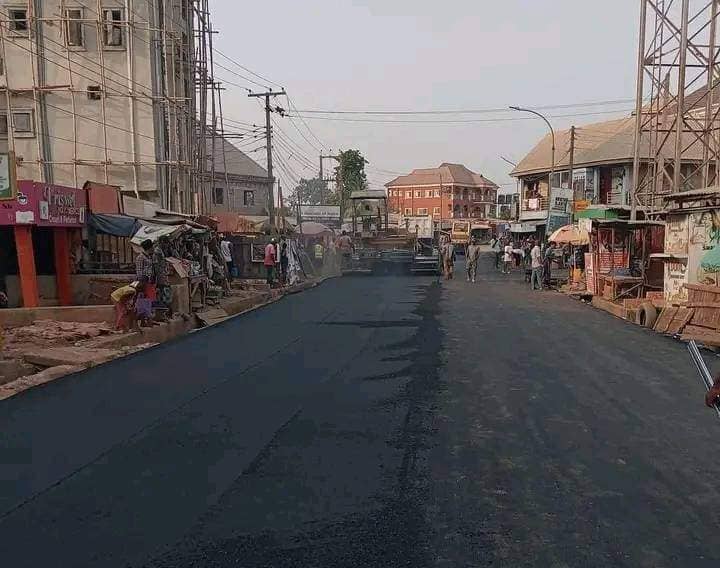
(0, 0, 216, 213)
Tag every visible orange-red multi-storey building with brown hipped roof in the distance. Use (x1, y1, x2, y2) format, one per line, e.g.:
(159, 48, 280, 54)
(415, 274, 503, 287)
(385, 163, 498, 220)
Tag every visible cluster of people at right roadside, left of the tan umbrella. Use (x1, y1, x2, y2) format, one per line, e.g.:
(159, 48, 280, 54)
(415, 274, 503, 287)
(490, 237, 557, 290)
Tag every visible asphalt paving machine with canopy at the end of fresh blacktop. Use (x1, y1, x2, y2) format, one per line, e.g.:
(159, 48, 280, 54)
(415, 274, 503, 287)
(342, 190, 440, 274)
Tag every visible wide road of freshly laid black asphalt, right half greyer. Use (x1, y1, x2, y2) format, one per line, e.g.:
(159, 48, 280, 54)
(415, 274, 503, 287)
(0, 255, 720, 568)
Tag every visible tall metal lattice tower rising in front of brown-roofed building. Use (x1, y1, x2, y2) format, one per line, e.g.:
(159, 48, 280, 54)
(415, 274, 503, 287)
(631, 0, 720, 217)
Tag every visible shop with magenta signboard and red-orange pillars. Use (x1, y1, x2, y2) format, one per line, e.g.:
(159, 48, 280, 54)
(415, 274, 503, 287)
(0, 181, 87, 307)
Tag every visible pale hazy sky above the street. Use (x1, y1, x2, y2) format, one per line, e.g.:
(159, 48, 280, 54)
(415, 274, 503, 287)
(210, 0, 639, 194)
